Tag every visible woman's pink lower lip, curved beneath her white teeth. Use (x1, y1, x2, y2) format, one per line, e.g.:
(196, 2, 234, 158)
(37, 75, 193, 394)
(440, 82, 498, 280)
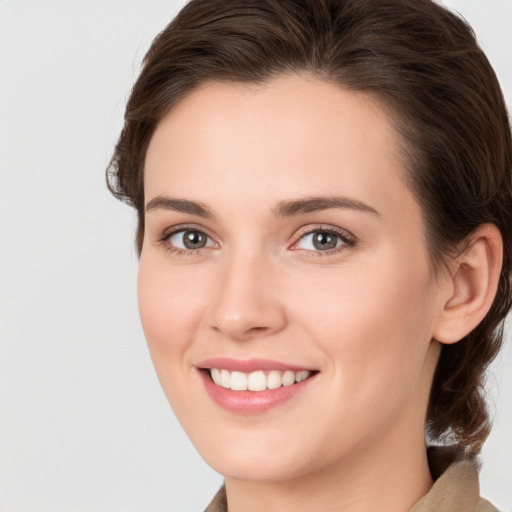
(199, 370, 316, 414)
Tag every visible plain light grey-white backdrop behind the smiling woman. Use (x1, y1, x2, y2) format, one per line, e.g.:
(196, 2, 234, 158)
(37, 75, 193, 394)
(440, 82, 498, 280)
(0, 0, 512, 512)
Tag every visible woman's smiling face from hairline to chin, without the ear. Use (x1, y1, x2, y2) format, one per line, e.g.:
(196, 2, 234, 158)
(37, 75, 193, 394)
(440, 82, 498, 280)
(138, 76, 442, 481)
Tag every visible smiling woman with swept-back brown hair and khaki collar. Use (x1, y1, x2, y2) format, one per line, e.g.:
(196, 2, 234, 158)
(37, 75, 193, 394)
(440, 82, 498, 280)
(109, 0, 512, 512)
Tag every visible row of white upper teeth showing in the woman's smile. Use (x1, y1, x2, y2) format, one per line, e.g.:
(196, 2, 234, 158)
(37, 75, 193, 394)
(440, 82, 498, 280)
(210, 368, 311, 391)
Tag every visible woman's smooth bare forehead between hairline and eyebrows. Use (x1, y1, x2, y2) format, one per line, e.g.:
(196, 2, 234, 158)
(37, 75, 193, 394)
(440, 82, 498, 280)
(145, 75, 418, 222)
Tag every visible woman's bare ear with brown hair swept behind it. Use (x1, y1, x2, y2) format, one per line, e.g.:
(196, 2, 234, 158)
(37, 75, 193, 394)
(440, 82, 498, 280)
(434, 224, 503, 344)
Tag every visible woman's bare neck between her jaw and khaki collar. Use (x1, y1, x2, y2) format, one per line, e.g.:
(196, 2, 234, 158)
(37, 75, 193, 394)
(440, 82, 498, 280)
(226, 428, 432, 512)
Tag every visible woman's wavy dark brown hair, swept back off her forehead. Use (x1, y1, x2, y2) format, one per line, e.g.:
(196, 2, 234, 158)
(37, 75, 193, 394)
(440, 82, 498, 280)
(107, 0, 512, 454)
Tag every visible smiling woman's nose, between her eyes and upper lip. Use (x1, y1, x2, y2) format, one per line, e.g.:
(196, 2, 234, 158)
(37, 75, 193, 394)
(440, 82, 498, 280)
(209, 251, 287, 341)
